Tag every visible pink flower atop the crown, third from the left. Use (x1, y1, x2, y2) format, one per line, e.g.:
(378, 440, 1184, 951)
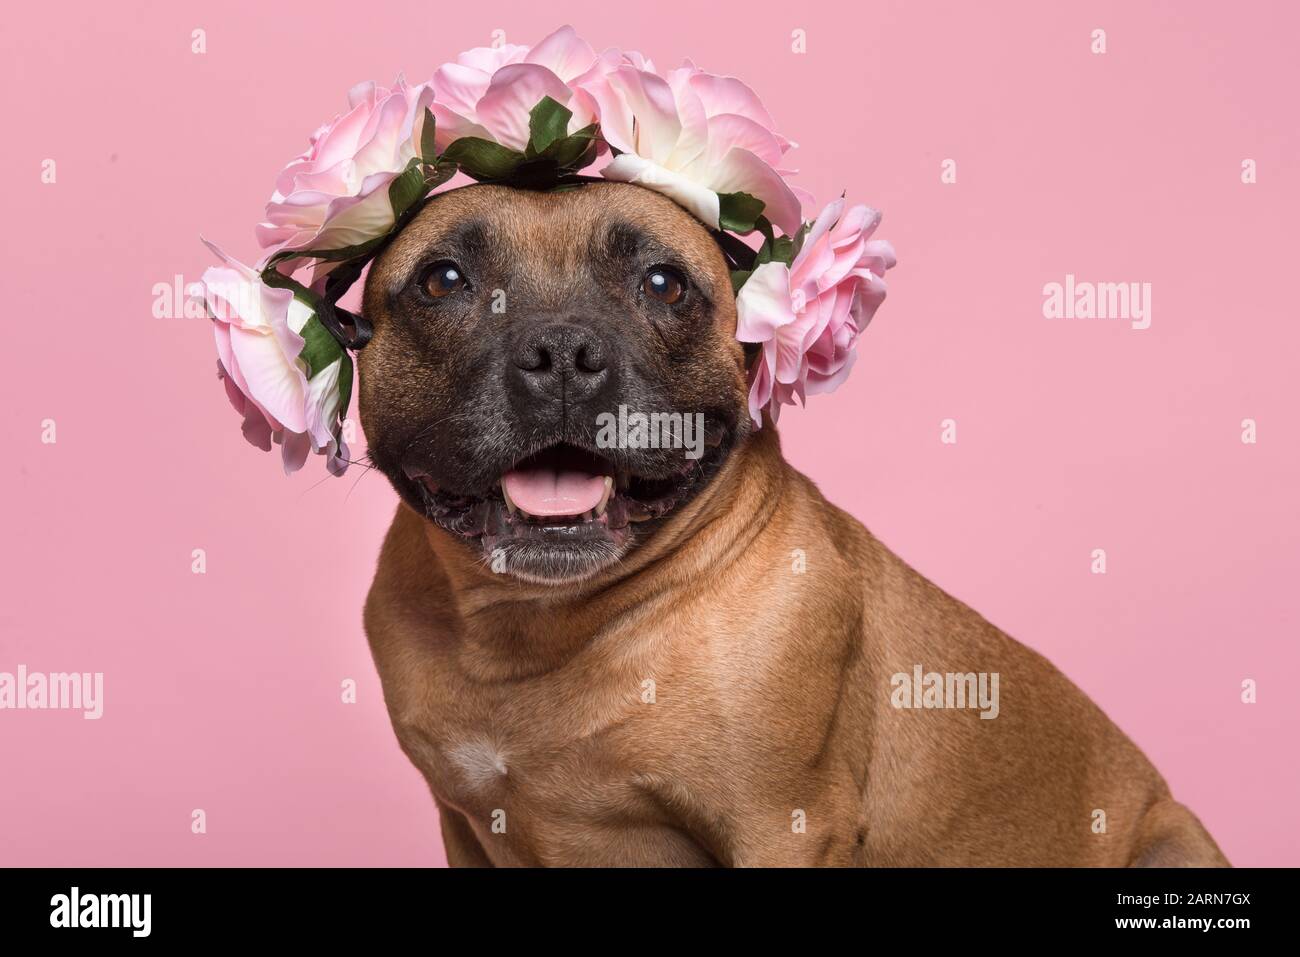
(433, 26, 595, 151)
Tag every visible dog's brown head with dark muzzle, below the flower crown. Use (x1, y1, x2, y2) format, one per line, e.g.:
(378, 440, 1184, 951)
(360, 183, 751, 583)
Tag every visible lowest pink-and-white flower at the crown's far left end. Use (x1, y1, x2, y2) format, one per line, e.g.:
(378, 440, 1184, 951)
(203, 243, 351, 475)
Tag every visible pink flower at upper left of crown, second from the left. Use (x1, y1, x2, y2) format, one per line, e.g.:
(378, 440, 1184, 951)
(257, 77, 433, 255)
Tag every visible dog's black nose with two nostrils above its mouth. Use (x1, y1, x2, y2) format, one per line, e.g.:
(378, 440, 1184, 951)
(511, 322, 614, 403)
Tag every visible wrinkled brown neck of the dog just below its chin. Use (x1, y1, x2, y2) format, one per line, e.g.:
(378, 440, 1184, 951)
(416, 425, 793, 679)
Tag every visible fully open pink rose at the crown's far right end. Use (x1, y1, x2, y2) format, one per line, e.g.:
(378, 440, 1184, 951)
(736, 199, 896, 425)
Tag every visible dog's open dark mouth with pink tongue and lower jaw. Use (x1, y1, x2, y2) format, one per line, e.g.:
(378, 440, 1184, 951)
(406, 433, 728, 581)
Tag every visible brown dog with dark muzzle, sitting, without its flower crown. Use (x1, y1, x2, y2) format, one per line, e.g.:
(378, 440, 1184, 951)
(360, 185, 1226, 866)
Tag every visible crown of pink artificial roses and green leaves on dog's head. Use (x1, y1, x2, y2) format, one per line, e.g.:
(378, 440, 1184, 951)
(203, 26, 894, 475)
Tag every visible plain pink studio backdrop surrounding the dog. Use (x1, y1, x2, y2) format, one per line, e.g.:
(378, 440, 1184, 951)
(0, 0, 1300, 865)
